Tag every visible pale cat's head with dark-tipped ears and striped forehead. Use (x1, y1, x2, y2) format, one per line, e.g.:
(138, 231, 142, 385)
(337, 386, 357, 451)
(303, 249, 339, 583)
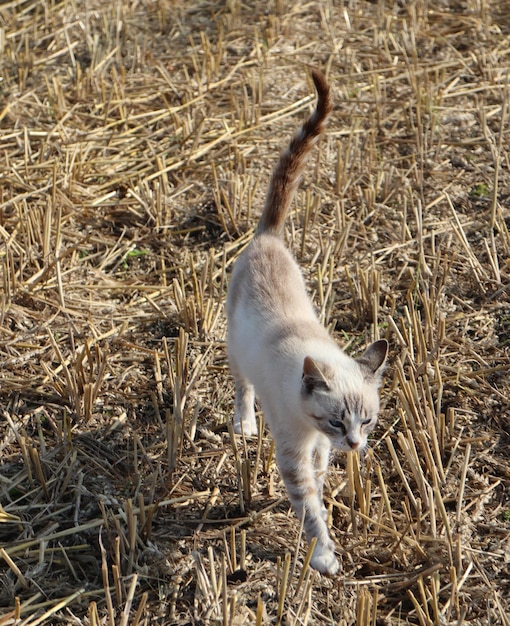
(301, 339, 388, 452)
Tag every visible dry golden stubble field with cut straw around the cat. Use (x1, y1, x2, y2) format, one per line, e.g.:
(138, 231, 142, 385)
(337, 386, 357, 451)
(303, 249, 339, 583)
(0, 0, 510, 626)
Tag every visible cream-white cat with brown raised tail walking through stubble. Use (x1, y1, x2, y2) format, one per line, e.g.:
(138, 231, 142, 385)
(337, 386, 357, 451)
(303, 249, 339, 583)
(226, 71, 388, 575)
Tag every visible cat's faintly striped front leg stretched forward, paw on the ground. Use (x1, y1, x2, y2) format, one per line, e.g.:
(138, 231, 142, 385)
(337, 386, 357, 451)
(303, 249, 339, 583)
(277, 446, 339, 576)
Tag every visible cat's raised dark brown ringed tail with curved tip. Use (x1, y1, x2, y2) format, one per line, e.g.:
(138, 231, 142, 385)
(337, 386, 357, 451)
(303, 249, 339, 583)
(257, 70, 333, 237)
